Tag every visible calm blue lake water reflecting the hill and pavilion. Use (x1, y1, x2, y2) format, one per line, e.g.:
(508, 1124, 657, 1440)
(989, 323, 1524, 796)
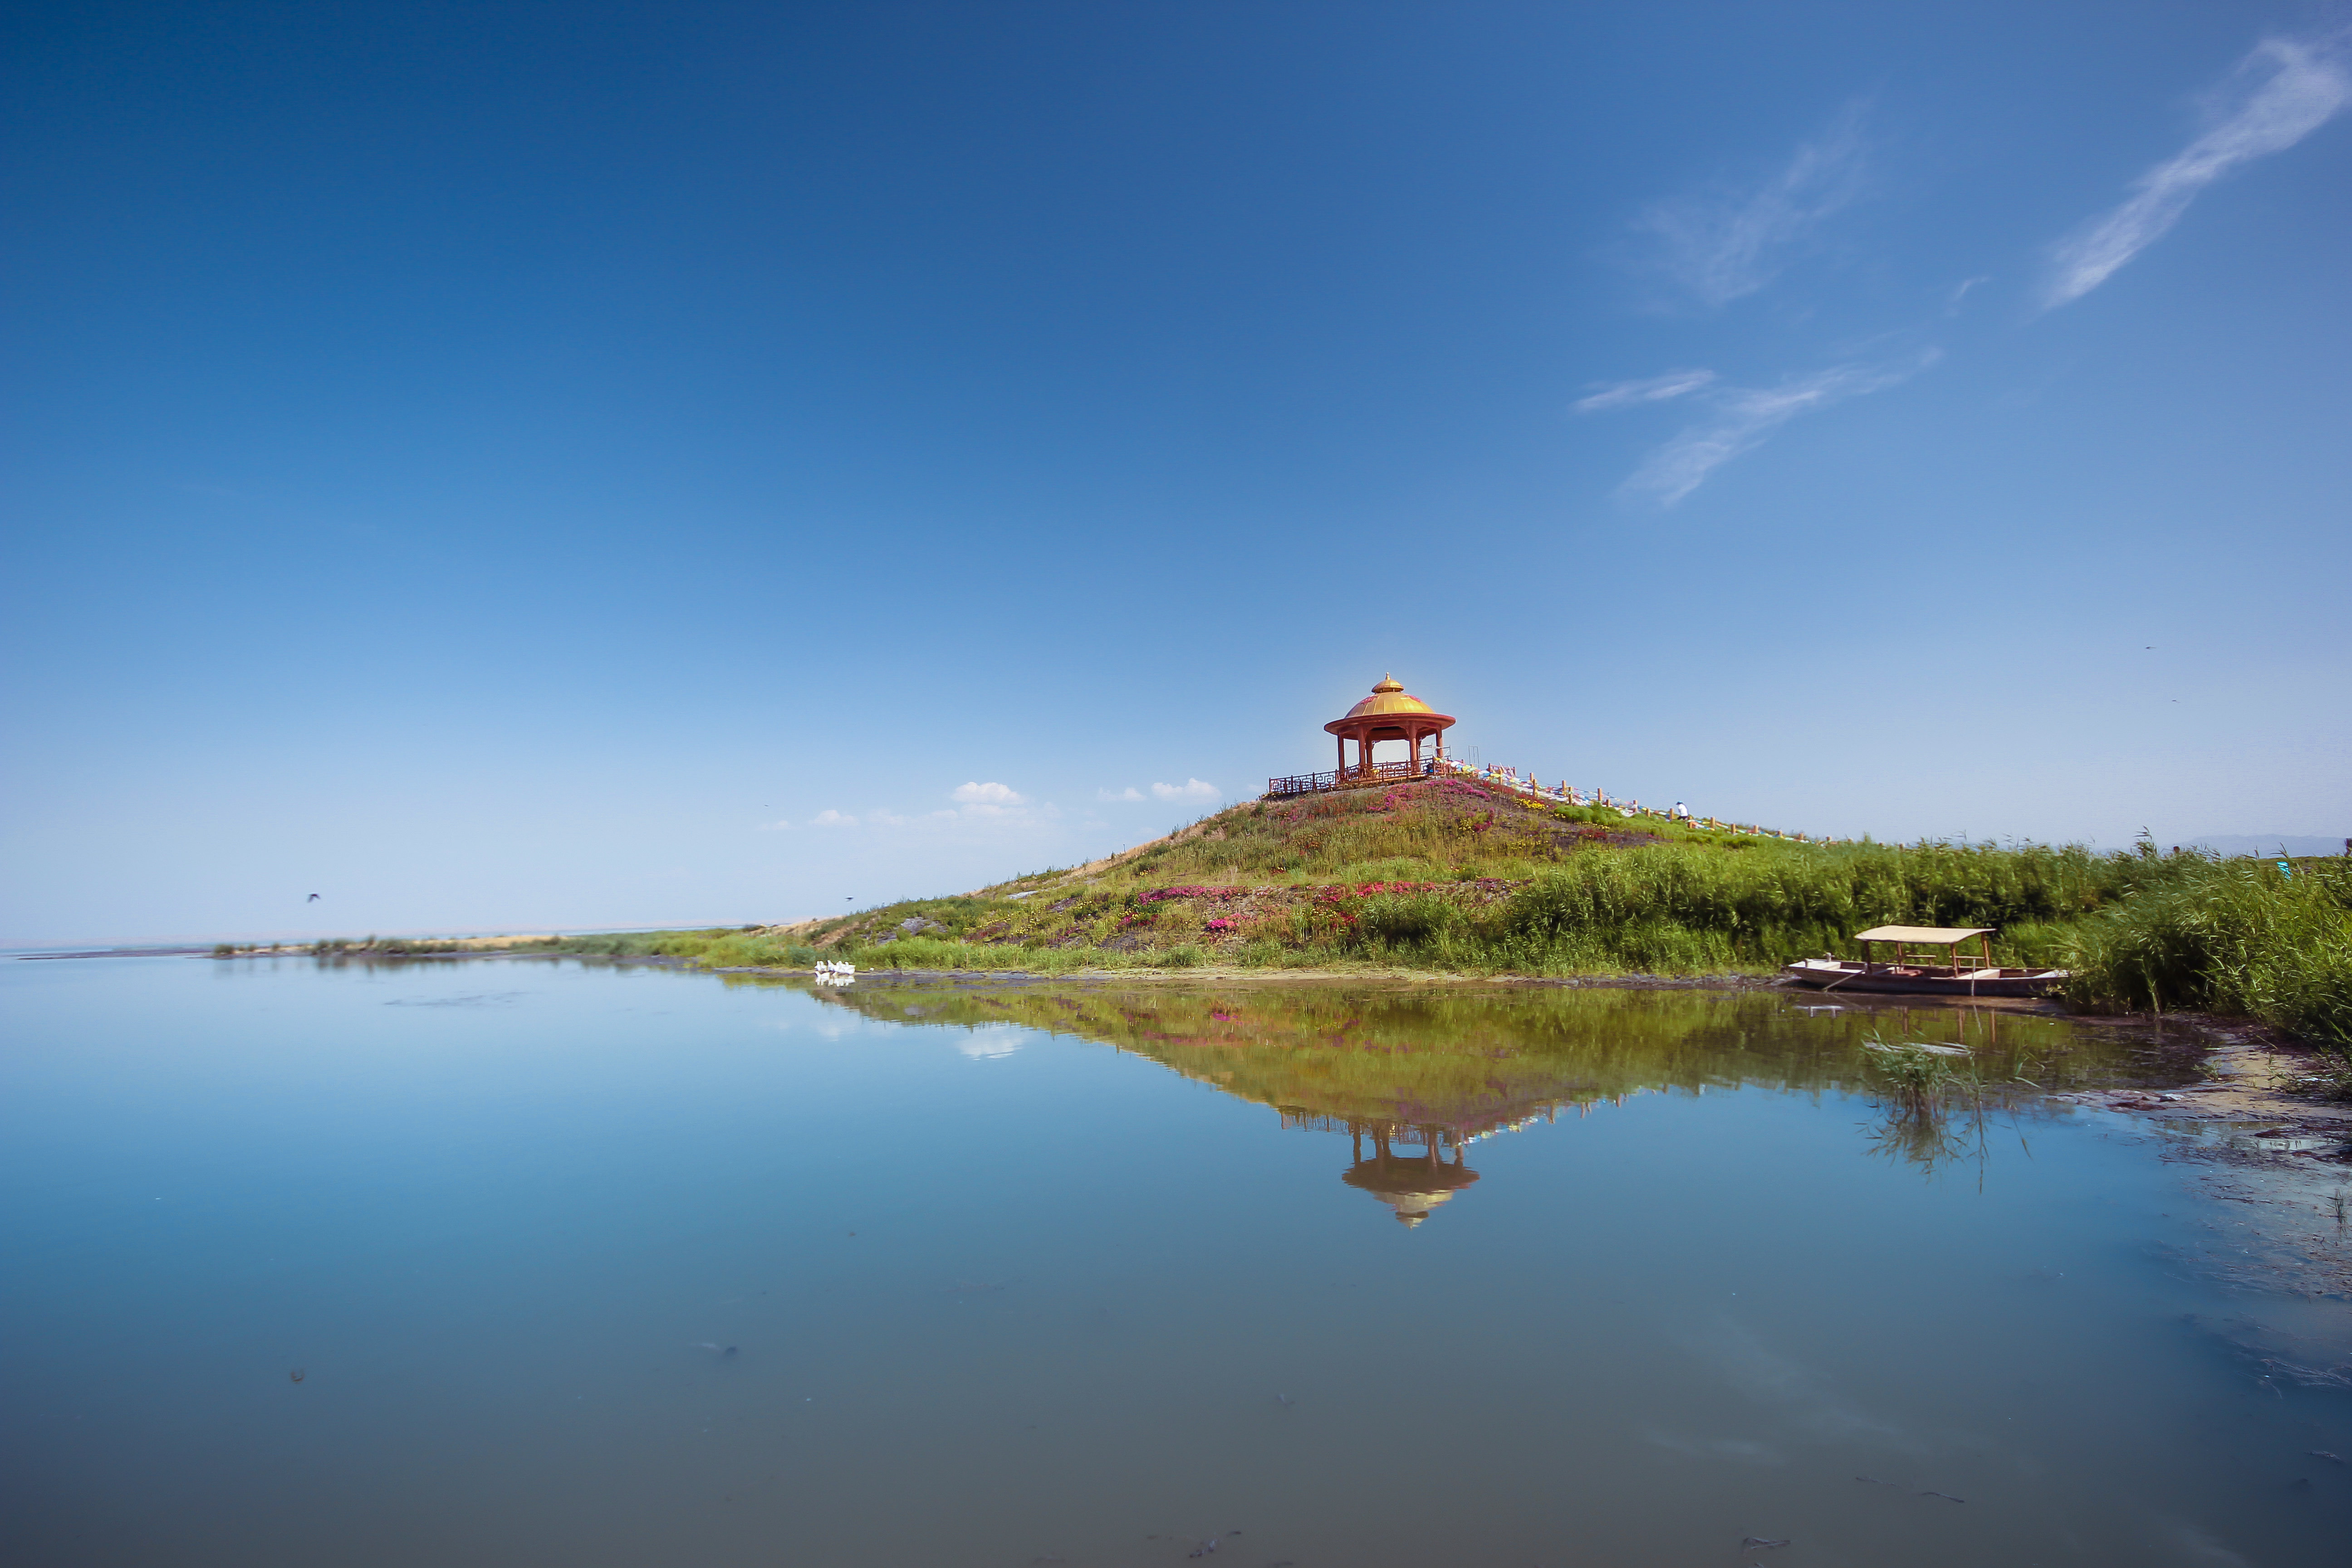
(0, 959, 2352, 1568)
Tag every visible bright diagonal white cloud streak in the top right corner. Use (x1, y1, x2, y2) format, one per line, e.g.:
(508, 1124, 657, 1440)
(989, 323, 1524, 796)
(2044, 33, 2352, 308)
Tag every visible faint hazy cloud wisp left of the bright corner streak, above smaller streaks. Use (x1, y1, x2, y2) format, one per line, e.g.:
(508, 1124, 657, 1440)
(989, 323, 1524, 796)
(1635, 103, 1865, 306)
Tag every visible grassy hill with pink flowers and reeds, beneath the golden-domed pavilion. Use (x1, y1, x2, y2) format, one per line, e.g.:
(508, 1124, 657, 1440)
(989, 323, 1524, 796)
(529, 778, 2352, 1041)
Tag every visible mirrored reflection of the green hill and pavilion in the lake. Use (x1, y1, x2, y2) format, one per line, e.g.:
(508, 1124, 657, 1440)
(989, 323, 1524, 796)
(731, 975, 2166, 1225)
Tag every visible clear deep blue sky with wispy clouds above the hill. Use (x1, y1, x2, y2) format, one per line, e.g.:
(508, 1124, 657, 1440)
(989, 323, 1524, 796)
(0, 2, 2352, 943)
